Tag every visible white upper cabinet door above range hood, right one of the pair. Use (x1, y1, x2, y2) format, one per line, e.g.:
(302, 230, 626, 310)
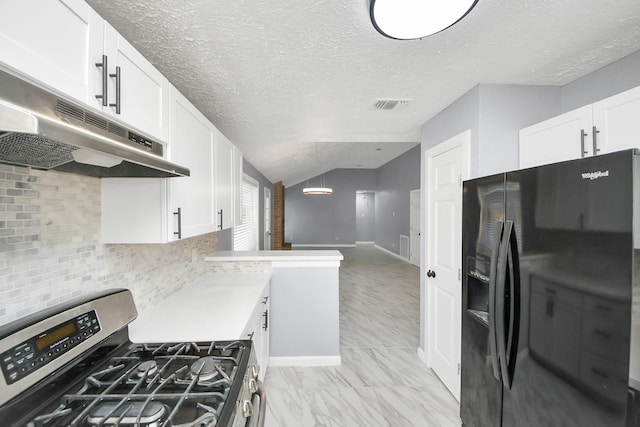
(88, 22, 170, 140)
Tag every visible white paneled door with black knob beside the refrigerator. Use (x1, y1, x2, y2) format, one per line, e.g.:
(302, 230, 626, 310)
(424, 131, 471, 400)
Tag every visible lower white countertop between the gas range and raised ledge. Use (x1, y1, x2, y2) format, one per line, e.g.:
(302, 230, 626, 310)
(129, 273, 271, 343)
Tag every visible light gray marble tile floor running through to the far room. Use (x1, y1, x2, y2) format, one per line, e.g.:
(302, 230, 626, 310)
(265, 245, 460, 427)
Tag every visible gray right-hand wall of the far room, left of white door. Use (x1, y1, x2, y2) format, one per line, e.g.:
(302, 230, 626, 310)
(375, 145, 420, 254)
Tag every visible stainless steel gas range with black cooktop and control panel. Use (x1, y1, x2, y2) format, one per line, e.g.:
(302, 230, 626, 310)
(0, 289, 266, 427)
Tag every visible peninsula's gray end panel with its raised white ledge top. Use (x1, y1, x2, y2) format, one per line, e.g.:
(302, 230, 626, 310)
(205, 250, 344, 366)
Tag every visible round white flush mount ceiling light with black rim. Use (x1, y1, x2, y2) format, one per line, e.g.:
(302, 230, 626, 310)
(369, 0, 478, 40)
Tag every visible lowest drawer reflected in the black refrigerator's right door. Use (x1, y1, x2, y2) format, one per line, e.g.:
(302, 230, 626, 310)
(580, 351, 628, 400)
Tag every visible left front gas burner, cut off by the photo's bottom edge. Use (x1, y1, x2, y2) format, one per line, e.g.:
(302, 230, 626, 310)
(87, 401, 167, 427)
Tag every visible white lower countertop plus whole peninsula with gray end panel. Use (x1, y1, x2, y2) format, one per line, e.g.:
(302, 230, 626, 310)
(129, 250, 343, 374)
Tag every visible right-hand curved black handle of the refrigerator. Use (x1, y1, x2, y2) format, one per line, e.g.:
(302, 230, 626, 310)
(500, 221, 520, 389)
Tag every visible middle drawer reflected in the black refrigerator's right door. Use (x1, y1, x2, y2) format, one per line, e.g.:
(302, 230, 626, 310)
(582, 313, 629, 362)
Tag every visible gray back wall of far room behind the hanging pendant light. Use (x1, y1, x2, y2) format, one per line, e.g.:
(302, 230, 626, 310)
(284, 169, 376, 246)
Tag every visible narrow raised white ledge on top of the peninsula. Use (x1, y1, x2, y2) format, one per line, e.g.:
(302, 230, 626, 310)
(204, 249, 344, 262)
